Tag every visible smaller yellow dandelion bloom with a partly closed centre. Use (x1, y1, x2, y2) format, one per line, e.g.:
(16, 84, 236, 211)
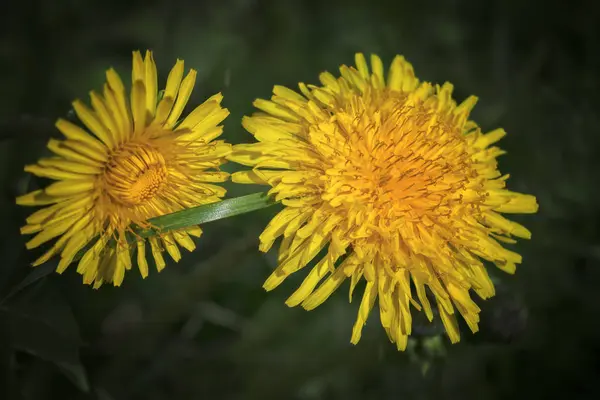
(17, 51, 231, 287)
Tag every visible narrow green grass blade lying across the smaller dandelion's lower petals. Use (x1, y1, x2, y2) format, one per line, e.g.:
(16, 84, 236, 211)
(137, 192, 277, 237)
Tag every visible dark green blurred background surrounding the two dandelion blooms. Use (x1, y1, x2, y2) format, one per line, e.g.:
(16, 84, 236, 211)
(0, 0, 600, 400)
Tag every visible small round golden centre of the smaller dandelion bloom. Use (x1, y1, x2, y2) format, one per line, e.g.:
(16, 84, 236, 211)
(104, 143, 168, 206)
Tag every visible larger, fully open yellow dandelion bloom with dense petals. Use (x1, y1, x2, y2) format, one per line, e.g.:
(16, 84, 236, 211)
(229, 54, 538, 350)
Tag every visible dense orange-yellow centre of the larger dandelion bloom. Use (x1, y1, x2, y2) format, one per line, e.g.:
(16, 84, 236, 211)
(314, 94, 472, 227)
